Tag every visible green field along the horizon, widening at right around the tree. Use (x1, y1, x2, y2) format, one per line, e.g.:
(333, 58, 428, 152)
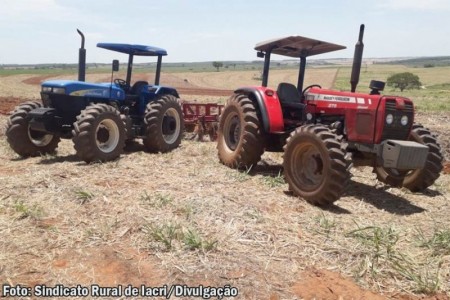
(0, 61, 450, 111)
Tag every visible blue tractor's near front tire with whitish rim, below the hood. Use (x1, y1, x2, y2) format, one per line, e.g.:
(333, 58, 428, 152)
(72, 103, 127, 163)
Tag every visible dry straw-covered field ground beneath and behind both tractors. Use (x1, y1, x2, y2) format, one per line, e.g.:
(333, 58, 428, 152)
(0, 68, 450, 299)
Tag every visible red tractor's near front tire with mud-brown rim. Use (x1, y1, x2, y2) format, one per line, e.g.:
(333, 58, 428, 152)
(283, 124, 351, 206)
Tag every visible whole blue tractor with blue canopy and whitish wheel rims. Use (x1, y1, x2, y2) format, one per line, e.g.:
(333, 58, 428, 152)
(6, 31, 184, 163)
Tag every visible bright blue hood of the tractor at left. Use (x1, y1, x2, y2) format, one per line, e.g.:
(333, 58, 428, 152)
(42, 80, 125, 100)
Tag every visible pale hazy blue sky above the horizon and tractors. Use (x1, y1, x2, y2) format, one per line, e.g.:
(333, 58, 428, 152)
(0, 0, 450, 64)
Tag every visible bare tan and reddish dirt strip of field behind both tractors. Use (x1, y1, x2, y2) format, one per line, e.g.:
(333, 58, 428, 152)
(0, 69, 337, 100)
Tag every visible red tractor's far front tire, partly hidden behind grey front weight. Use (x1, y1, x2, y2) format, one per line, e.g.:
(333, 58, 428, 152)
(374, 124, 443, 192)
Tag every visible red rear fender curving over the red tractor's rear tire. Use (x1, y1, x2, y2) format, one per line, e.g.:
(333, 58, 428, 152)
(234, 87, 284, 133)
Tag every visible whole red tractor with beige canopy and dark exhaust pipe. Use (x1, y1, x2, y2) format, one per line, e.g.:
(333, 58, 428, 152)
(217, 25, 442, 205)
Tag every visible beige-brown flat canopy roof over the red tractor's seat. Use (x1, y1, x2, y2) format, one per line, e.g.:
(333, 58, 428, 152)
(255, 36, 346, 57)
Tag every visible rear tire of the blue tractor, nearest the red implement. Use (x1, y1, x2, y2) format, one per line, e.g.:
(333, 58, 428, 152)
(143, 95, 184, 153)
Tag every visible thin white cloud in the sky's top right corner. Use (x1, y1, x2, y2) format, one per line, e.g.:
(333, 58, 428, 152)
(377, 0, 450, 11)
